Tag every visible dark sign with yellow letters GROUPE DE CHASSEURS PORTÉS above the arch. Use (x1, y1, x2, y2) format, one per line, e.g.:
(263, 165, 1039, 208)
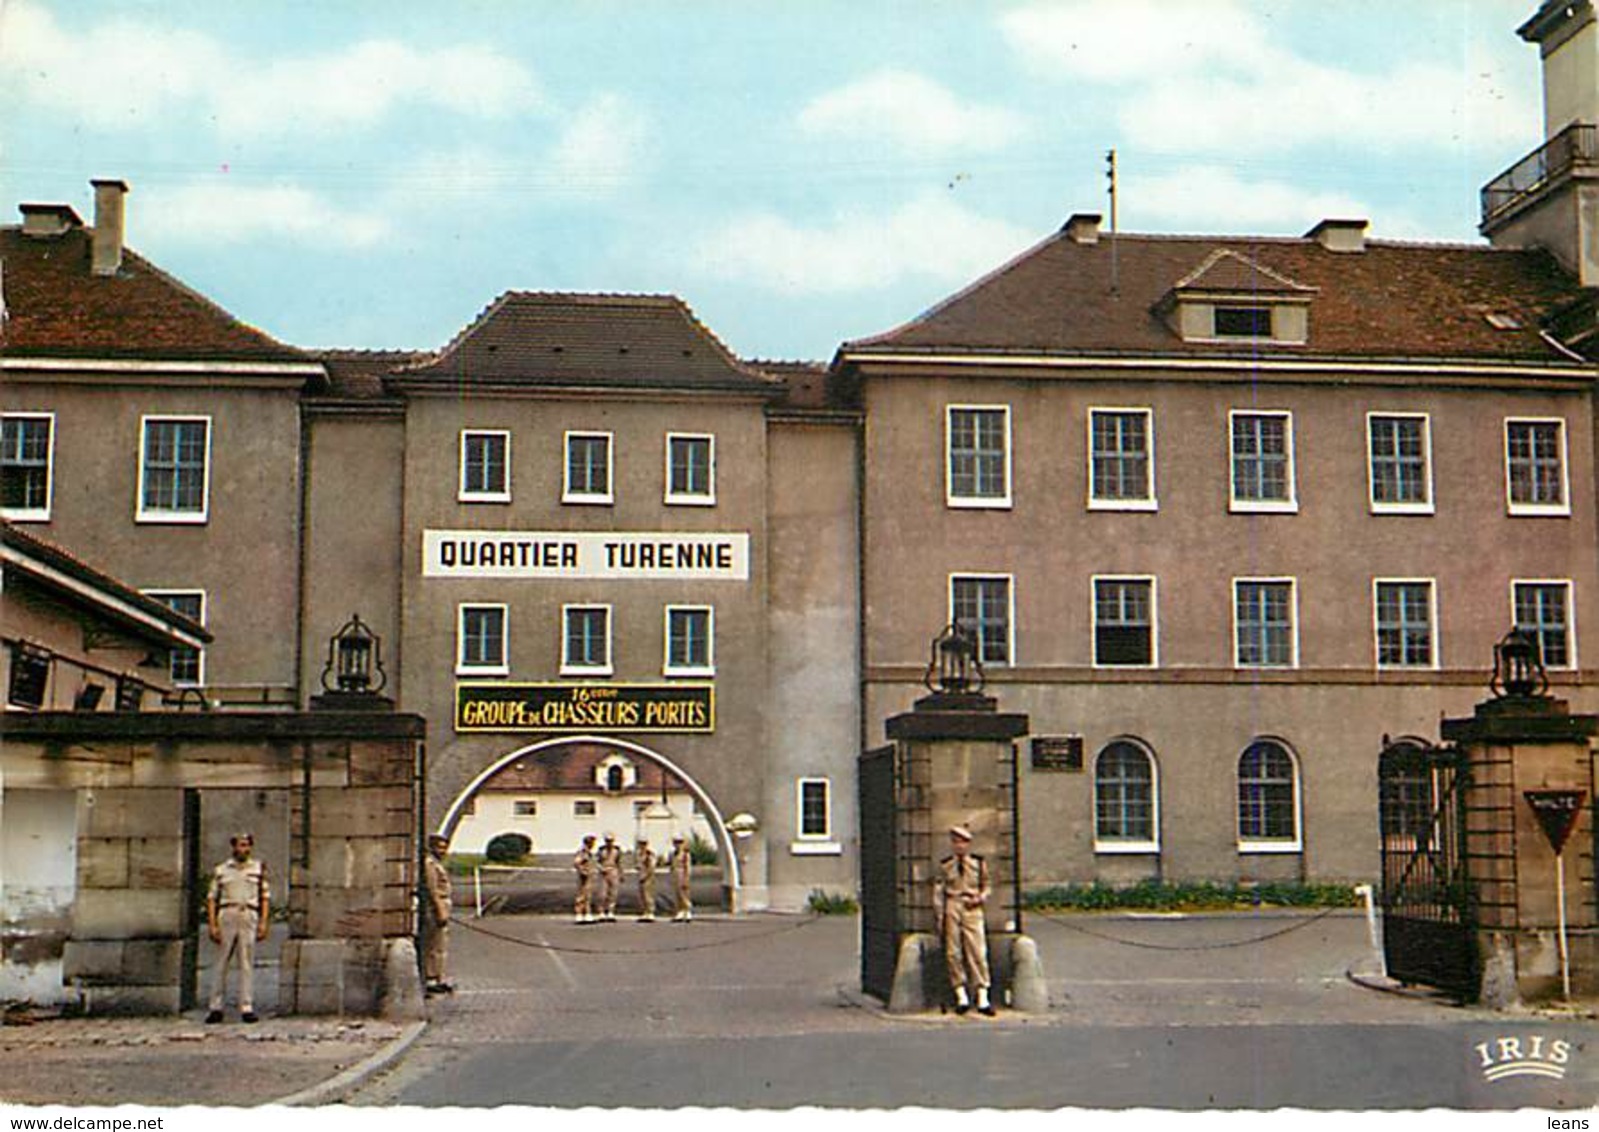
(456, 684, 716, 734)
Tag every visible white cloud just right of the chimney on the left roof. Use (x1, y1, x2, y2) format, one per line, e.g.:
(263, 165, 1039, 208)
(138, 179, 390, 248)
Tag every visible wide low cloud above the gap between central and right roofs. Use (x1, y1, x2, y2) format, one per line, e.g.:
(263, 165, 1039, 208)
(694, 193, 1033, 294)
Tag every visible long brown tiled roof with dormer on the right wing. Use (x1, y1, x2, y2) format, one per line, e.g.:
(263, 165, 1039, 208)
(843, 233, 1581, 361)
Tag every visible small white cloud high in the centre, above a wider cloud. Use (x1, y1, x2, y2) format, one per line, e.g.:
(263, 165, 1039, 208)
(800, 70, 1023, 152)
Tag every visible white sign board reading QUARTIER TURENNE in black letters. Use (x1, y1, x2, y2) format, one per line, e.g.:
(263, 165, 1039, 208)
(422, 531, 750, 582)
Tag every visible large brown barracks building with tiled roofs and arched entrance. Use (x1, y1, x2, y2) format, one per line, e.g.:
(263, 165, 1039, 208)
(9, 2, 1599, 908)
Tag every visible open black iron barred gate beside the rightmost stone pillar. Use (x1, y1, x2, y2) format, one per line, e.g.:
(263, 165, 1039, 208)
(1377, 740, 1482, 1002)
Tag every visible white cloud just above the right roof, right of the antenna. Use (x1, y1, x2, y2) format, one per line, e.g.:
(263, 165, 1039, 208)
(1121, 165, 1372, 235)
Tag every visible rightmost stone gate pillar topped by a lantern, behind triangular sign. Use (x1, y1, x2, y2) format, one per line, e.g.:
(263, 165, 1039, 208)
(1442, 633, 1599, 1007)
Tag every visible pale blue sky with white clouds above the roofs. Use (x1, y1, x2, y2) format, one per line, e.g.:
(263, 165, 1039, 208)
(0, 0, 1543, 361)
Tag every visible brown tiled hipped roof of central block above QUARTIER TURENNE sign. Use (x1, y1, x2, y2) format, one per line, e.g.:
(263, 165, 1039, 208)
(400, 291, 782, 395)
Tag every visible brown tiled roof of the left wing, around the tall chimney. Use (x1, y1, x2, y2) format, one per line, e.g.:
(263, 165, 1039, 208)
(0, 225, 309, 361)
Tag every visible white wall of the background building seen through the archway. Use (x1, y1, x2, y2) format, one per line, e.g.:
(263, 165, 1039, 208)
(449, 790, 715, 854)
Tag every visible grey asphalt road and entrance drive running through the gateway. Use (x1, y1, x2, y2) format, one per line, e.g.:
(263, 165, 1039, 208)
(353, 915, 1599, 1110)
